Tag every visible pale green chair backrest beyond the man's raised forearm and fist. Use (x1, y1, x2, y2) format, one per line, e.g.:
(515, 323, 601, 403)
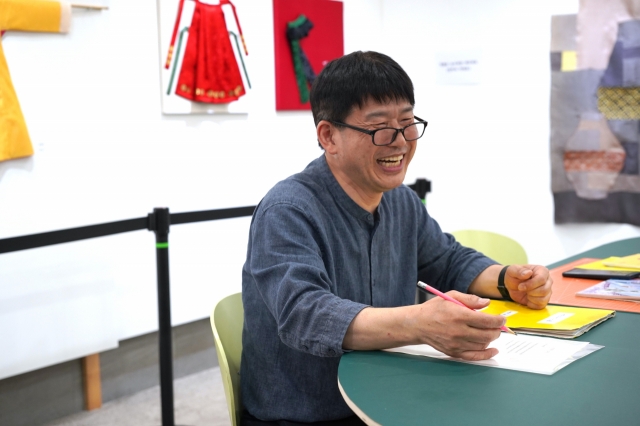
(451, 229, 528, 265)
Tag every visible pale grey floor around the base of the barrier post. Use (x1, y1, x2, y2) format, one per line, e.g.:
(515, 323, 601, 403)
(48, 367, 231, 426)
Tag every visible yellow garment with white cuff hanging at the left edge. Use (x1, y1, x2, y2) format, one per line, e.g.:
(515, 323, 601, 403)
(0, 0, 71, 161)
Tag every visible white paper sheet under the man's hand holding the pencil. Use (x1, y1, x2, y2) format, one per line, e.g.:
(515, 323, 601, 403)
(385, 333, 602, 375)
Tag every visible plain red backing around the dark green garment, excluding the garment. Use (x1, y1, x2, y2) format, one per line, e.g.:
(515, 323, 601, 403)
(273, 0, 344, 111)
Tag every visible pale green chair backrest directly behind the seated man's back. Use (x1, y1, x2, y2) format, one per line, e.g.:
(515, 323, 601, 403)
(211, 293, 244, 426)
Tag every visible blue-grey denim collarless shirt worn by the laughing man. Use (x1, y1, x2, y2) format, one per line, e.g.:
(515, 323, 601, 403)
(240, 155, 495, 422)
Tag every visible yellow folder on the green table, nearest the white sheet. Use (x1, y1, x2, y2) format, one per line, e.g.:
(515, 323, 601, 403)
(481, 300, 616, 339)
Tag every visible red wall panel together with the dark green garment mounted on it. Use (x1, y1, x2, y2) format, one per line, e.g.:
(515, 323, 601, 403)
(273, 0, 344, 111)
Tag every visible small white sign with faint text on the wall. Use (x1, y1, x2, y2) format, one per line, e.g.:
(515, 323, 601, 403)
(435, 49, 482, 85)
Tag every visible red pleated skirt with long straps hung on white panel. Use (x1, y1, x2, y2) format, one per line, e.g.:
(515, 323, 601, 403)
(165, 0, 248, 104)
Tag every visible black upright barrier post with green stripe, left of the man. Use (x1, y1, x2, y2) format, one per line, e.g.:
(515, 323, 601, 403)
(148, 208, 175, 426)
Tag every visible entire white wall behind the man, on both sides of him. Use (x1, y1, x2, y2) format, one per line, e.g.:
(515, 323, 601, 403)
(0, 0, 640, 378)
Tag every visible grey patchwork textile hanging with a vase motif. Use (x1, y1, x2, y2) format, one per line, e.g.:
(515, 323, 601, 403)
(550, 0, 640, 225)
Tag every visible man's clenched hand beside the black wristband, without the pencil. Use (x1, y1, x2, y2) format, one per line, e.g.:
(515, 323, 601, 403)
(504, 265, 553, 309)
